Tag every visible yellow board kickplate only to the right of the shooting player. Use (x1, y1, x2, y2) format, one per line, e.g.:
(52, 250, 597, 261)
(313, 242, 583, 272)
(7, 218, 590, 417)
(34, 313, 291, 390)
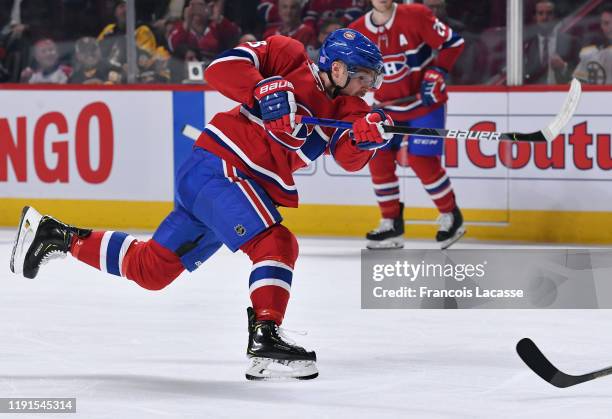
(281, 205, 612, 245)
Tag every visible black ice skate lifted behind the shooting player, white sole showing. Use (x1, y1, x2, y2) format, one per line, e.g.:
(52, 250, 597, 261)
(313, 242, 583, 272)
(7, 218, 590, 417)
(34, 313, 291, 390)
(11, 207, 91, 278)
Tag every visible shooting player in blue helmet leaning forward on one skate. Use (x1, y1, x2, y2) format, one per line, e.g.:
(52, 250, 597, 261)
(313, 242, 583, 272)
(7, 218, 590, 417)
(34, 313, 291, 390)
(10, 29, 392, 379)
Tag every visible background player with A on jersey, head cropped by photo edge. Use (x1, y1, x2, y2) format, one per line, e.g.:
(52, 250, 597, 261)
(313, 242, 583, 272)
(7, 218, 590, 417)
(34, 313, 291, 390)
(350, 0, 465, 249)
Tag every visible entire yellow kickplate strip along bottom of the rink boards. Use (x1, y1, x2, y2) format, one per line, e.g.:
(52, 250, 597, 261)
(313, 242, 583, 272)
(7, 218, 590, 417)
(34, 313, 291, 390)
(0, 198, 612, 245)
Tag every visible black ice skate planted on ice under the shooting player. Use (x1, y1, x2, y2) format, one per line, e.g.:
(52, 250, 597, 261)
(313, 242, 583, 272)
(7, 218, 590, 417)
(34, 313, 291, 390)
(246, 307, 319, 380)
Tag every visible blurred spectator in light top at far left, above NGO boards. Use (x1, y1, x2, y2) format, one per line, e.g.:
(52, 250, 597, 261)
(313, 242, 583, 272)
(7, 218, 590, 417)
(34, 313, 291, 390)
(20, 38, 72, 84)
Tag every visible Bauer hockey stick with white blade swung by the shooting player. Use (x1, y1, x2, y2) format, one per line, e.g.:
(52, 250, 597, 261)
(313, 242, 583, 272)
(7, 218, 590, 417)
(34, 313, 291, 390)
(295, 79, 582, 142)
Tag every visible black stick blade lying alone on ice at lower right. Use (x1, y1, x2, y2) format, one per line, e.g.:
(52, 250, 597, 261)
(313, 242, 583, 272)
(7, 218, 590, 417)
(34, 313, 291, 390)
(516, 338, 612, 388)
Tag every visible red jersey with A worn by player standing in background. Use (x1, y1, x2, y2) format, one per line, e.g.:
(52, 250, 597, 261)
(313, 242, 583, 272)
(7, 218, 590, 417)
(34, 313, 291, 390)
(350, 4, 464, 121)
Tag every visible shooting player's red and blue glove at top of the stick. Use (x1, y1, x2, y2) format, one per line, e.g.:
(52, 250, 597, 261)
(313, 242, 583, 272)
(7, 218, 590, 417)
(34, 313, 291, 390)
(253, 76, 297, 133)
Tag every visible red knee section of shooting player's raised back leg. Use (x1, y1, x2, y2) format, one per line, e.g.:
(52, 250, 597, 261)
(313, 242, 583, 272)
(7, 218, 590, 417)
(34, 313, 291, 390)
(123, 240, 185, 291)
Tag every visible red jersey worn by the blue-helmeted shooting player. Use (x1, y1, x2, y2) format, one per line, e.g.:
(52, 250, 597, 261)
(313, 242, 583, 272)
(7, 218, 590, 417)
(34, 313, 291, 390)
(196, 35, 374, 207)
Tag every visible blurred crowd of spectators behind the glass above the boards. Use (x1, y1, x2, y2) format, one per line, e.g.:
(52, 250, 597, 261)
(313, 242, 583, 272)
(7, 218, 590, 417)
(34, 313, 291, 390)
(0, 0, 612, 84)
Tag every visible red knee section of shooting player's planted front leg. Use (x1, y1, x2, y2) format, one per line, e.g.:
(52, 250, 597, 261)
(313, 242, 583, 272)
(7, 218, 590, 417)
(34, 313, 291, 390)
(240, 224, 299, 268)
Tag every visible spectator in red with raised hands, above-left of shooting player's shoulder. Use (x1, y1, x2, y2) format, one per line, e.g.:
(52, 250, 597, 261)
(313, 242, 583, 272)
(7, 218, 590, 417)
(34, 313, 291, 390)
(168, 0, 240, 66)
